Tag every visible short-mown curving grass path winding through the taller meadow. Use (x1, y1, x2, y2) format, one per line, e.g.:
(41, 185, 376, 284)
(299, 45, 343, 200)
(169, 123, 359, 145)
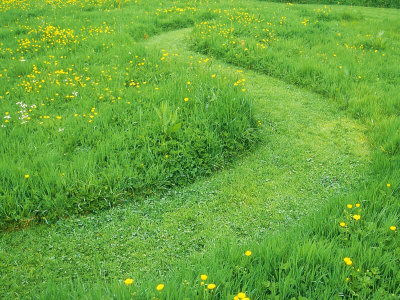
(0, 29, 369, 298)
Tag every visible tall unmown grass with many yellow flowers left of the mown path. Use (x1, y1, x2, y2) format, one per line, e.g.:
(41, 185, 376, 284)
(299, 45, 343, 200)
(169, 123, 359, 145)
(0, 1, 257, 226)
